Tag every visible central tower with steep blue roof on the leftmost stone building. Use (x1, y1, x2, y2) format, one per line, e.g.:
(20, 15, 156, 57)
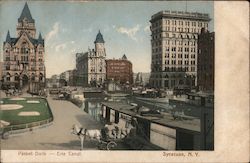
(16, 2, 36, 38)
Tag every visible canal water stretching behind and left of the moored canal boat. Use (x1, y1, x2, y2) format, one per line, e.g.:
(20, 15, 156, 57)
(81, 97, 206, 121)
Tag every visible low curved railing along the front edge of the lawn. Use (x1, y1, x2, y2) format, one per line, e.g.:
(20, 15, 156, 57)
(2, 117, 53, 132)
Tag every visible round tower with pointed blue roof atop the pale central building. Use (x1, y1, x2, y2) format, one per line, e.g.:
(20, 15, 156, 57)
(94, 30, 106, 57)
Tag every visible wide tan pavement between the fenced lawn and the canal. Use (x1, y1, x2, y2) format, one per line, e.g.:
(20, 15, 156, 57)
(1, 94, 102, 150)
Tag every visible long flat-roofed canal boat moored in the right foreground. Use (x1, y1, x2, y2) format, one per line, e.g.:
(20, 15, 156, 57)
(101, 102, 203, 150)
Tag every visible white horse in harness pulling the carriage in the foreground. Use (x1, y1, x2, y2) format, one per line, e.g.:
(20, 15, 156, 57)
(71, 124, 102, 150)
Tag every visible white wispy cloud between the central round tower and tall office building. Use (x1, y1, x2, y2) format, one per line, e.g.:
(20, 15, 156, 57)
(113, 24, 140, 41)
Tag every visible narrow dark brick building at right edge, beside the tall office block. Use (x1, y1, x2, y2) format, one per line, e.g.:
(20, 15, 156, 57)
(197, 28, 215, 92)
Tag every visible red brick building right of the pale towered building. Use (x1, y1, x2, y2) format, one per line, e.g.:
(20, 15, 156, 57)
(106, 54, 133, 84)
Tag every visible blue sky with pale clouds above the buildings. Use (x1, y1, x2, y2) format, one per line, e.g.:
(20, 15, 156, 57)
(0, 1, 214, 77)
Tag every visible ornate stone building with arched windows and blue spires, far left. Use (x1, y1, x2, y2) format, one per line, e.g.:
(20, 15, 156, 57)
(2, 3, 45, 92)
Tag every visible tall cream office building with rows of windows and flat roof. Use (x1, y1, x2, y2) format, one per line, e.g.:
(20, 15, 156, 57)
(150, 11, 210, 89)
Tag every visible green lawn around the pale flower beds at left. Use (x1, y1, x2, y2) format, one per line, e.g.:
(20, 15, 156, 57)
(0, 97, 53, 126)
